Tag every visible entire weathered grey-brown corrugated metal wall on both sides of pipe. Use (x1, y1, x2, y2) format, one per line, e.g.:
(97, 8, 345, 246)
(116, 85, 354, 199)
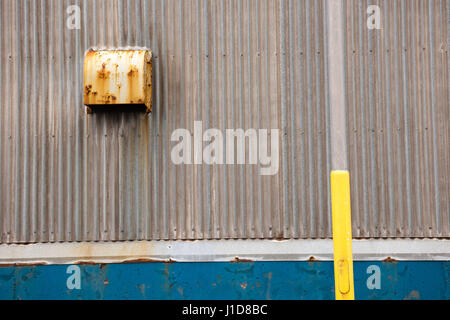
(0, 0, 450, 243)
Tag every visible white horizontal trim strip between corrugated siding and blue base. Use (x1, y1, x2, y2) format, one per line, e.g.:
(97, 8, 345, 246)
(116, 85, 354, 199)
(0, 239, 450, 265)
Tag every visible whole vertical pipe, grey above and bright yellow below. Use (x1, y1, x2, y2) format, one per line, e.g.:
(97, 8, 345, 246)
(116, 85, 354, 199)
(327, 0, 355, 300)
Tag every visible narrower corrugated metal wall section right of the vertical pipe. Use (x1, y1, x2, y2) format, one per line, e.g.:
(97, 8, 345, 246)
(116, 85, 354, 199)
(345, 0, 450, 237)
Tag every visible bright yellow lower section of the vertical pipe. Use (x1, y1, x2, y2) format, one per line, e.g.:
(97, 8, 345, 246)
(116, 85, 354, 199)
(331, 170, 355, 300)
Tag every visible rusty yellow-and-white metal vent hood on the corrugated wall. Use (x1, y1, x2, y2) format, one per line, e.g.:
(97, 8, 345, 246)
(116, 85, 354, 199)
(83, 50, 152, 112)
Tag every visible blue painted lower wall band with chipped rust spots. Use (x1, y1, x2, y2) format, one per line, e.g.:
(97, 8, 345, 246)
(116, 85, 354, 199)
(0, 261, 450, 300)
